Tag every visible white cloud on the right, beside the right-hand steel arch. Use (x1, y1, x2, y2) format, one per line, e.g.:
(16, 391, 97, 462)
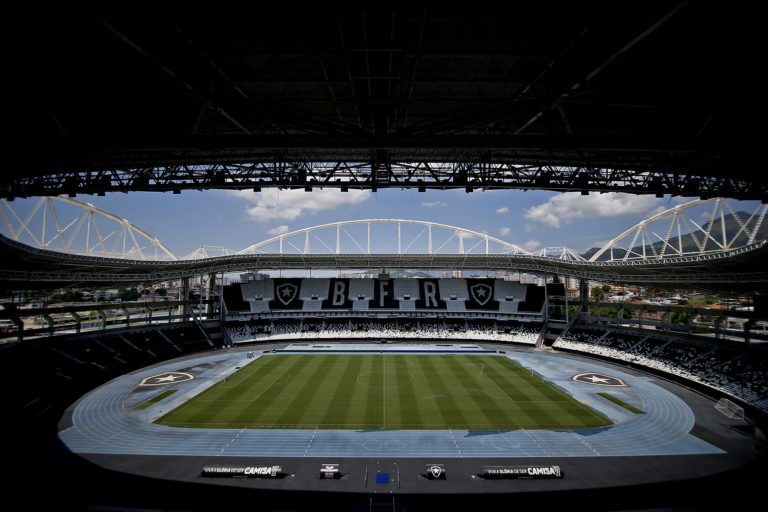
(523, 192, 663, 228)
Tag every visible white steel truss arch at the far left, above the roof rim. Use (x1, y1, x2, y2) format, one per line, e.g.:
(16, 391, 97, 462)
(0, 196, 178, 260)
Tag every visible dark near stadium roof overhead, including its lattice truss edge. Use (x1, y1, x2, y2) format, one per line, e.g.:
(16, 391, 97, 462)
(9, 0, 768, 199)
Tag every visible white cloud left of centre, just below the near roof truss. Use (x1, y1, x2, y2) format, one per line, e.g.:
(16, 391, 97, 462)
(230, 188, 371, 222)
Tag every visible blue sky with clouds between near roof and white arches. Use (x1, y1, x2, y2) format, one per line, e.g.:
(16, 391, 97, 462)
(3, 189, 757, 256)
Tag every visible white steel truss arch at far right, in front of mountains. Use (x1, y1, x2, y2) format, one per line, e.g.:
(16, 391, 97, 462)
(589, 197, 768, 261)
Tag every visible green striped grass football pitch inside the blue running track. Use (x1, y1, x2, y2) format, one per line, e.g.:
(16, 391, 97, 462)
(157, 354, 610, 430)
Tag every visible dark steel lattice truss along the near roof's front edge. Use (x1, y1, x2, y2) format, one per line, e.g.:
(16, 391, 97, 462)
(0, 161, 768, 199)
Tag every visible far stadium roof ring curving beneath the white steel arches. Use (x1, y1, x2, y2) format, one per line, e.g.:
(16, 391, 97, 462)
(0, 236, 768, 291)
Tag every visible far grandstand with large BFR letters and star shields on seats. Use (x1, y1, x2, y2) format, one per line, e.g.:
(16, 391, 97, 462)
(223, 278, 544, 345)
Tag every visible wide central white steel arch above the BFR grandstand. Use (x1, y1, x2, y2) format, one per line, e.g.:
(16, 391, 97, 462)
(237, 219, 530, 255)
